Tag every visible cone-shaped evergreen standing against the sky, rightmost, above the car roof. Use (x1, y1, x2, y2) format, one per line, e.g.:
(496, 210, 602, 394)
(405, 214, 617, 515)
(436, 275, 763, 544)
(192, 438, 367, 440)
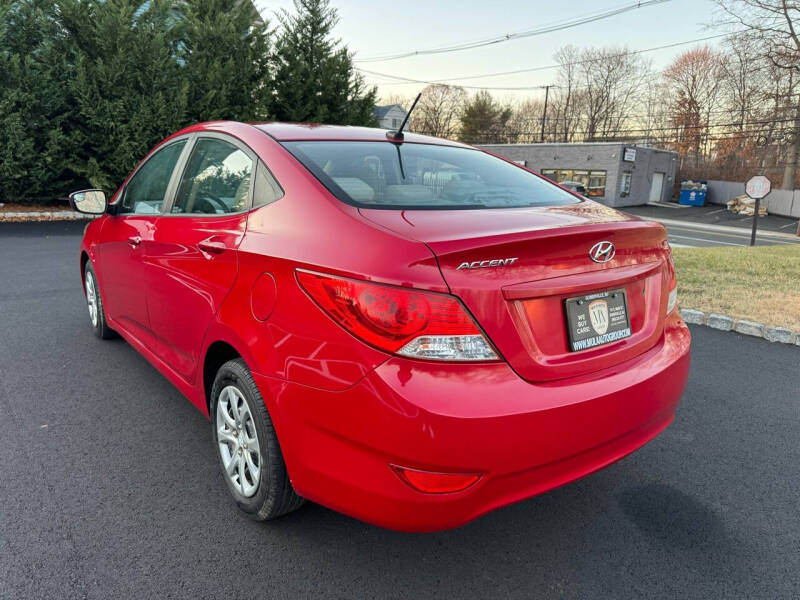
(271, 0, 377, 126)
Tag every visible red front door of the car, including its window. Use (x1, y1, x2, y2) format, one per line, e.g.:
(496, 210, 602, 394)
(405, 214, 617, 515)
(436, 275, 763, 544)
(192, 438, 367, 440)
(96, 138, 188, 345)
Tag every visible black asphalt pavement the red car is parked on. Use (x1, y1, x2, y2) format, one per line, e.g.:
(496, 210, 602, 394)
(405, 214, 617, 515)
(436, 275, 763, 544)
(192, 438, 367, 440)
(0, 223, 800, 599)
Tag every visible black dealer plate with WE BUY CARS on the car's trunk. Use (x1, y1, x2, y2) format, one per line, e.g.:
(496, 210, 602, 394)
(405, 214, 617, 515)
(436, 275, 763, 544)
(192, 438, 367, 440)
(564, 289, 631, 352)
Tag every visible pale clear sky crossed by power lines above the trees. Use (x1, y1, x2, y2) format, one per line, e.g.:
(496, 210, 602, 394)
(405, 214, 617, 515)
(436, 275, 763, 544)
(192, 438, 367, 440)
(257, 0, 720, 99)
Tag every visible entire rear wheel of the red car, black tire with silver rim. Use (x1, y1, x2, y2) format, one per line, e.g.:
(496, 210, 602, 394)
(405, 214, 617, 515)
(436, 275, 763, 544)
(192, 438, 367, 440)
(210, 359, 305, 521)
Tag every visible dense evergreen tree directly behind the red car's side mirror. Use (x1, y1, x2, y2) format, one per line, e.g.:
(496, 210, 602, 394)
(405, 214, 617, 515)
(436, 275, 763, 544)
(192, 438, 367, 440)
(59, 0, 189, 191)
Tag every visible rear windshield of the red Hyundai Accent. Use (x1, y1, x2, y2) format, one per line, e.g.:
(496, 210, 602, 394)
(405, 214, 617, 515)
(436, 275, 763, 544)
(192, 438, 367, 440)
(283, 141, 581, 209)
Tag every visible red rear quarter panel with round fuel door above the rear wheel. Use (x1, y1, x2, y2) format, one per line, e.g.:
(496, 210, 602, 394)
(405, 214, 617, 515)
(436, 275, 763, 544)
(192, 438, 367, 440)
(216, 128, 447, 391)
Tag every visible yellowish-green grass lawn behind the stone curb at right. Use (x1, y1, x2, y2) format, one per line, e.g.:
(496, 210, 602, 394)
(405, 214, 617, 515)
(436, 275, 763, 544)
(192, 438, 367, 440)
(672, 245, 800, 331)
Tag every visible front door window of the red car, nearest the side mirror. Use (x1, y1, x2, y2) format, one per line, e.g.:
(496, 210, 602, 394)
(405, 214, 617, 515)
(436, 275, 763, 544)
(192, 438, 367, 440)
(119, 140, 186, 215)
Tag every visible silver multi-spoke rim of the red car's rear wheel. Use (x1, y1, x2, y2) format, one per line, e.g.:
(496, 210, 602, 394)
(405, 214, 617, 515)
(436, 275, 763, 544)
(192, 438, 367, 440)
(216, 385, 261, 498)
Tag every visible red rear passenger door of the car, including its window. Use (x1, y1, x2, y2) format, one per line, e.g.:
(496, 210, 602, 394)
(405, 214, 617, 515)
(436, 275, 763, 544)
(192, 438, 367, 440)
(147, 133, 256, 382)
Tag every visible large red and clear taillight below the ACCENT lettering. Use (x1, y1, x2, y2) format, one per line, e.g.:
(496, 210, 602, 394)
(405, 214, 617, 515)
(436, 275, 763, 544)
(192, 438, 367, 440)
(297, 270, 498, 361)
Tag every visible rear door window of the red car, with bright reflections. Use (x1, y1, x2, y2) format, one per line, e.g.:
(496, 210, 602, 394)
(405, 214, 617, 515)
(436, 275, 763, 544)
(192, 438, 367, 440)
(172, 138, 253, 215)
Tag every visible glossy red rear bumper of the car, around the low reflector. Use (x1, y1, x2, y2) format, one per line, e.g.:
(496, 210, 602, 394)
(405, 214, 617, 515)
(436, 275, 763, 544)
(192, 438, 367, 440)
(256, 311, 690, 531)
